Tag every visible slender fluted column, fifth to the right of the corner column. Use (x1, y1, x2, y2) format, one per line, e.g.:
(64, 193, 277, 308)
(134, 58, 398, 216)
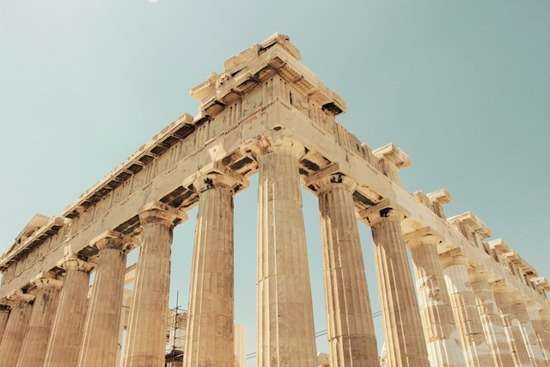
(469, 268, 514, 367)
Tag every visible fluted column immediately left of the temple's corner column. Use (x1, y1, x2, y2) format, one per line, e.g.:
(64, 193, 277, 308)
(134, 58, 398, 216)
(184, 177, 235, 367)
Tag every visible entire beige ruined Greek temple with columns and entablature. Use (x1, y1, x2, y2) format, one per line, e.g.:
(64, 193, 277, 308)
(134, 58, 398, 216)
(0, 34, 550, 367)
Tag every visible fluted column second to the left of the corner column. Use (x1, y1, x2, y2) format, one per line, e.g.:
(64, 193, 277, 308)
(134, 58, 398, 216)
(125, 203, 184, 367)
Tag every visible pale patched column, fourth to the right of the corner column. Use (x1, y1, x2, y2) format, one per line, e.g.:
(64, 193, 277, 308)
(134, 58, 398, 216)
(440, 251, 493, 367)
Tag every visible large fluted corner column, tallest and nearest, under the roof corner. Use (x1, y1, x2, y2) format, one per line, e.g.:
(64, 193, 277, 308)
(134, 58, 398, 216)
(257, 142, 317, 367)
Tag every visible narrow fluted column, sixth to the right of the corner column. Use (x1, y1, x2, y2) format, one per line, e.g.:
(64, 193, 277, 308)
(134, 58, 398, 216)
(493, 283, 533, 367)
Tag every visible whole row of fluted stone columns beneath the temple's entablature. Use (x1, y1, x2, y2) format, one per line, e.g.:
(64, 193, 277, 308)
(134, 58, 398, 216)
(0, 141, 550, 367)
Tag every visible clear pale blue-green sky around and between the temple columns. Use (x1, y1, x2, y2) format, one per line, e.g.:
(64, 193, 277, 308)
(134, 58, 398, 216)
(0, 0, 550, 365)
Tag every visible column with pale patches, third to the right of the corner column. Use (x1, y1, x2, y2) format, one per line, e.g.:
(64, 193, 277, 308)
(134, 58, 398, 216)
(407, 235, 465, 367)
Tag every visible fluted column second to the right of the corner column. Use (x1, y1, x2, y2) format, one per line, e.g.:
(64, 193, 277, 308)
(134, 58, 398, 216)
(362, 204, 429, 367)
